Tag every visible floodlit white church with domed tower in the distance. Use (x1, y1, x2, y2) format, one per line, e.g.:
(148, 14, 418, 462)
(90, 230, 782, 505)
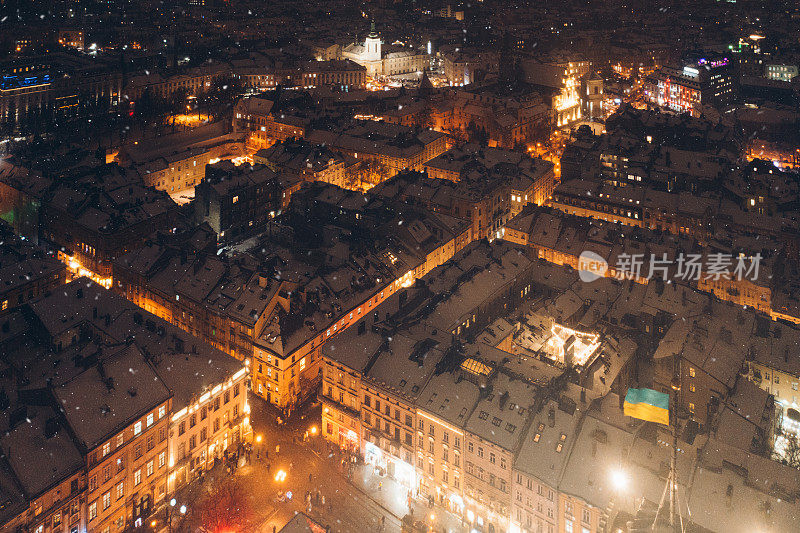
(342, 22, 430, 78)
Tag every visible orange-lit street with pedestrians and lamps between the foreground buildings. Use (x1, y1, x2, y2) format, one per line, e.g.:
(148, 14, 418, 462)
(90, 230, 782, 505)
(173, 396, 466, 533)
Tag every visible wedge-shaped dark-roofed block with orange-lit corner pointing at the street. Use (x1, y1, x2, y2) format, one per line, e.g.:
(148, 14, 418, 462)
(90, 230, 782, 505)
(115, 183, 471, 411)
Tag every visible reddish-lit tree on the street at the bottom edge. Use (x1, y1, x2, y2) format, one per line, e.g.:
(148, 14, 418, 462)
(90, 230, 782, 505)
(194, 478, 254, 533)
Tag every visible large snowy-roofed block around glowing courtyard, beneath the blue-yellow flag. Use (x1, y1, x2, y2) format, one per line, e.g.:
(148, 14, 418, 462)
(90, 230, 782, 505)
(320, 237, 796, 533)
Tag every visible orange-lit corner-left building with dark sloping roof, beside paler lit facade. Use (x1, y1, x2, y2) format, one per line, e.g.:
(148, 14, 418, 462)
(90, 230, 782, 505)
(54, 347, 172, 532)
